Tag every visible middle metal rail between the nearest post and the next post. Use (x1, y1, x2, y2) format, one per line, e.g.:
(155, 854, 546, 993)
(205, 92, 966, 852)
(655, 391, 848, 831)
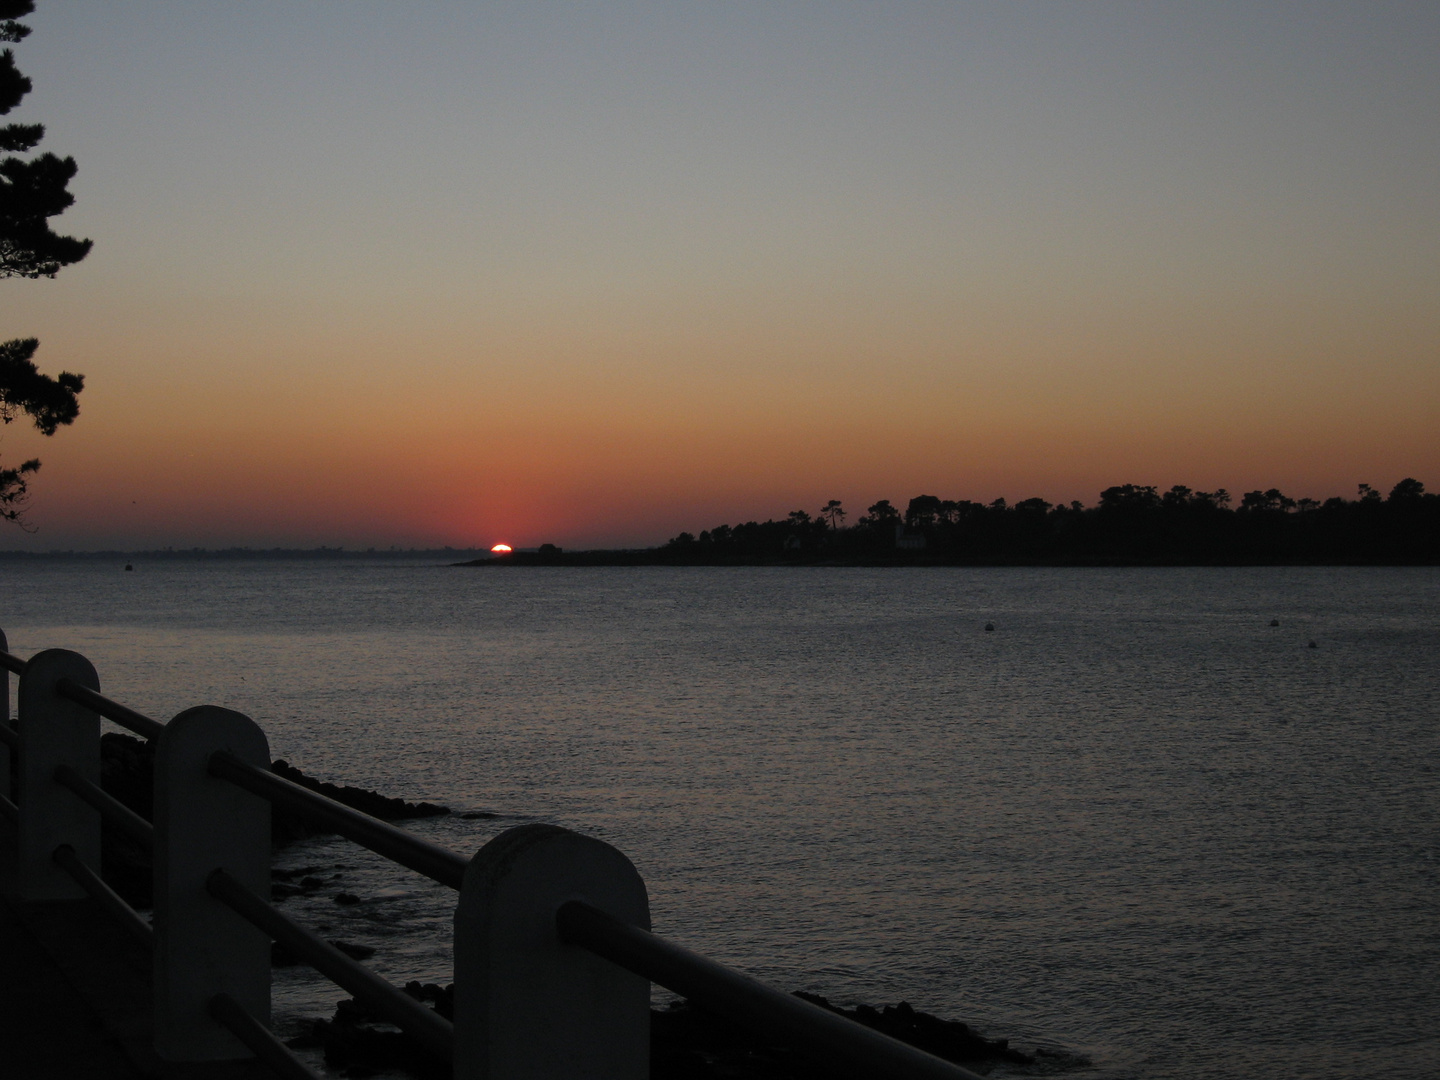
(204, 870, 455, 1061)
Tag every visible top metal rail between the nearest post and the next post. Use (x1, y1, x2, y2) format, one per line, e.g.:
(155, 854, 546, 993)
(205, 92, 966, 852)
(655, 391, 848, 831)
(210, 750, 469, 888)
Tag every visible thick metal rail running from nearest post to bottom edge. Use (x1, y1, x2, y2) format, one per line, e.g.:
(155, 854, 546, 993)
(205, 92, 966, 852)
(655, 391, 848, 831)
(554, 900, 981, 1080)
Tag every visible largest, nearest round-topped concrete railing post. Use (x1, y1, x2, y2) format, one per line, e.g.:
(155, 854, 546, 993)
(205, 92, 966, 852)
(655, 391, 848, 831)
(455, 825, 649, 1080)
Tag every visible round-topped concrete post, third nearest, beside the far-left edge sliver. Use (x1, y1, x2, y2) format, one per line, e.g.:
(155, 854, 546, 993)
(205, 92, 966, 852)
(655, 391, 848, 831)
(16, 649, 99, 900)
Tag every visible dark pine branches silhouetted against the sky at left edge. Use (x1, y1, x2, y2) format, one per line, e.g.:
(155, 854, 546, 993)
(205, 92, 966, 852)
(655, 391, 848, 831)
(0, 0, 91, 524)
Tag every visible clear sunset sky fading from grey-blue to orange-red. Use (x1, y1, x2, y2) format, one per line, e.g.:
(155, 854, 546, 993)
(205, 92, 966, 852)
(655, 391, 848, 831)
(0, 0, 1440, 550)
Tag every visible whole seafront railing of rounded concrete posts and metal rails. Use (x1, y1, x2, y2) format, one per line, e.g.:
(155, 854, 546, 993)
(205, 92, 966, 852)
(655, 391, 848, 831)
(0, 634, 975, 1080)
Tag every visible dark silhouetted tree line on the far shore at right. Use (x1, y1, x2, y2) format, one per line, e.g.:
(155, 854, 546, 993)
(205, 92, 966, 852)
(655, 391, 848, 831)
(652, 478, 1440, 566)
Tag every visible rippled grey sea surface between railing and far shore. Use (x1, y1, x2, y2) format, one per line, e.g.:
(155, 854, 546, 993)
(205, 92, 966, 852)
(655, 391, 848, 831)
(0, 560, 1440, 1080)
